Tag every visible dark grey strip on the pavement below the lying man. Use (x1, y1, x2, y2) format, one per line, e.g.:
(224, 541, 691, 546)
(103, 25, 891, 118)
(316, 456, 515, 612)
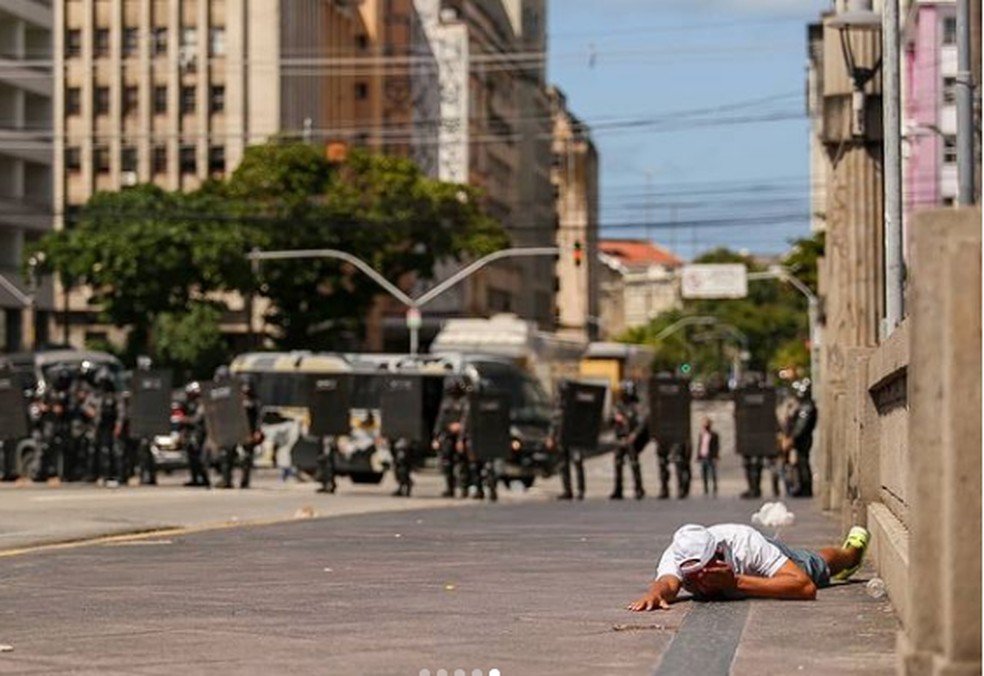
(654, 601, 749, 676)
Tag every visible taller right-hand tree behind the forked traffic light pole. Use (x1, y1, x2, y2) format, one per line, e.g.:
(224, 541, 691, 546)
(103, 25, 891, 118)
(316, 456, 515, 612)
(226, 143, 508, 349)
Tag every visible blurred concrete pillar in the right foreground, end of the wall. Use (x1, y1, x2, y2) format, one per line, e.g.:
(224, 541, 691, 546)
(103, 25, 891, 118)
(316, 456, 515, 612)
(900, 208, 981, 675)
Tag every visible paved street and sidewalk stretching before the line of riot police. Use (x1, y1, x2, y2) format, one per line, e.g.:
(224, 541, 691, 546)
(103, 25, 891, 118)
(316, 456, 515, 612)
(0, 406, 897, 676)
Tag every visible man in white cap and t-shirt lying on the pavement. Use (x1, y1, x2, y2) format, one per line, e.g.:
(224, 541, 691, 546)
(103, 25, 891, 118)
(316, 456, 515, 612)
(628, 523, 870, 611)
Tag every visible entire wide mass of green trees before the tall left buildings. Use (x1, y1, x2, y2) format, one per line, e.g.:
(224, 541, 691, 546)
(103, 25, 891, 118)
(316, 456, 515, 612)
(31, 140, 508, 364)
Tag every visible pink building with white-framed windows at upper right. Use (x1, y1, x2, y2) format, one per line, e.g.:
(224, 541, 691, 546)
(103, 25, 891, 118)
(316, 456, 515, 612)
(902, 0, 957, 220)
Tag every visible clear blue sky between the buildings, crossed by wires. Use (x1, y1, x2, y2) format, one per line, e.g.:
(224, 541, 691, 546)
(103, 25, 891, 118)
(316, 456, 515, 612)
(547, 0, 832, 260)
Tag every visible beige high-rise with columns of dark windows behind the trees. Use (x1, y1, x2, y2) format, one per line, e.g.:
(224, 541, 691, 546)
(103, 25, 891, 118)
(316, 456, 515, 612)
(53, 0, 369, 345)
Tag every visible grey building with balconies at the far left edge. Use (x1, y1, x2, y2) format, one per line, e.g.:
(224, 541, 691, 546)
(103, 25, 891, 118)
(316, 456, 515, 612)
(0, 0, 54, 352)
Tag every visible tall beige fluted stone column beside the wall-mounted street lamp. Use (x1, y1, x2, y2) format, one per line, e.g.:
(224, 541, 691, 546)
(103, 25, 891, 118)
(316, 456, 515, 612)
(814, 17, 883, 509)
